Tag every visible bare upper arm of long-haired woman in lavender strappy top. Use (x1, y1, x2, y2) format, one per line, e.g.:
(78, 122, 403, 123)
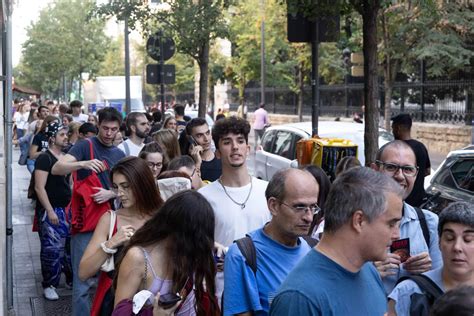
(114, 247, 145, 307)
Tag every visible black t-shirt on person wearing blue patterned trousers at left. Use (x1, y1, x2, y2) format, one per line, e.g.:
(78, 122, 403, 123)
(33, 150, 71, 209)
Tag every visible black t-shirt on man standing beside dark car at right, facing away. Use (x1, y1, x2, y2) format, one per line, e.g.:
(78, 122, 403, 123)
(405, 139, 431, 207)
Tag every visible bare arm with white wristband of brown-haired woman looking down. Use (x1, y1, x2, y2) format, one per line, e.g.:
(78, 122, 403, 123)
(79, 212, 132, 281)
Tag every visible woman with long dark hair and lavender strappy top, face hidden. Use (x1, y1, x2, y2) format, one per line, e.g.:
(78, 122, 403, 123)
(113, 190, 219, 316)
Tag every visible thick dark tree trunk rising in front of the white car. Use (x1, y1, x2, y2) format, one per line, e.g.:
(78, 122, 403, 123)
(361, 0, 380, 166)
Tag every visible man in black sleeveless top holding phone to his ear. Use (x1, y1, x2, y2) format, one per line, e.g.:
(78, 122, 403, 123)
(182, 117, 222, 182)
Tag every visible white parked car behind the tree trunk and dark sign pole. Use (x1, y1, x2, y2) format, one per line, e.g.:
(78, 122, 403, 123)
(255, 121, 393, 180)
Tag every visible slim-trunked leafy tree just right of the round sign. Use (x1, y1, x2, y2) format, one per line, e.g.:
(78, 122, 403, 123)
(96, 0, 227, 117)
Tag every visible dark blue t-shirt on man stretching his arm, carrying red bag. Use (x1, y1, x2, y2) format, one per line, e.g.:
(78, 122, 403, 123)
(68, 136, 125, 189)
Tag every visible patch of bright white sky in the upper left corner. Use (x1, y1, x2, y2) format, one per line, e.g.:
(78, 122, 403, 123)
(12, 0, 53, 67)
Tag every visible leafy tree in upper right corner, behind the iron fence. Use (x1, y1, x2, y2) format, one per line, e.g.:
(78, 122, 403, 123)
(381, 0, 474, 130)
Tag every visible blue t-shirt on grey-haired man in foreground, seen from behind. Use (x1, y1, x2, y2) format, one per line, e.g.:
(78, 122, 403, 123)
(270, 250, 387, 316)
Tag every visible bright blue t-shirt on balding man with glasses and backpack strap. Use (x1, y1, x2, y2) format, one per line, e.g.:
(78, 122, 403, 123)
(224, 228, 311, 315)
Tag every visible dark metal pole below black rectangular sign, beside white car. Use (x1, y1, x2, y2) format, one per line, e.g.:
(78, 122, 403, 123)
(311, 19, 319, 136)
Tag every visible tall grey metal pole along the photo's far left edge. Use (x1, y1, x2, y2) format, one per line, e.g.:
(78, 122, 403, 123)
(3, 11, 13, 310)
